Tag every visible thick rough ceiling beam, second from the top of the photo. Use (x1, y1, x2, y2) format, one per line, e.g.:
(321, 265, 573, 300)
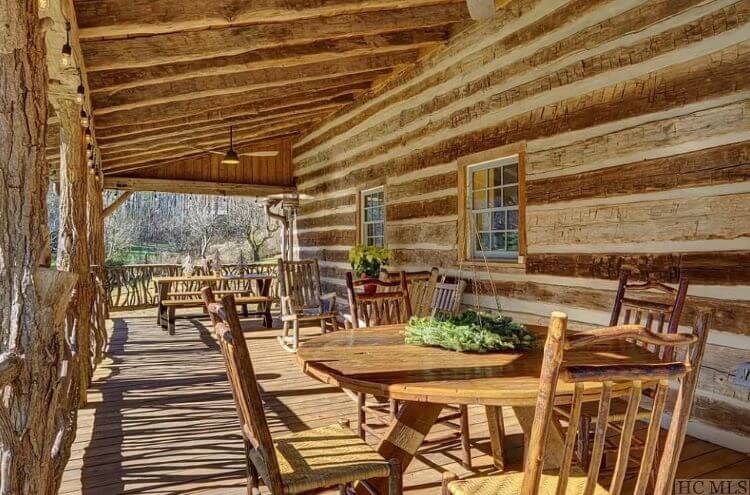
(82, 2, 469, 70)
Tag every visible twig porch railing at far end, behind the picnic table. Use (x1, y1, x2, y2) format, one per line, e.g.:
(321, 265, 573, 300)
(105, 263, 278, 311)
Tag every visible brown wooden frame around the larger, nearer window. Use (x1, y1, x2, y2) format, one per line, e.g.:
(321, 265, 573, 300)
(457, 143, 527, 266)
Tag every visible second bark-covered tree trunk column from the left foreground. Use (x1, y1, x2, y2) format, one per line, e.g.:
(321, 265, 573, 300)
(56, 100, 93, 405)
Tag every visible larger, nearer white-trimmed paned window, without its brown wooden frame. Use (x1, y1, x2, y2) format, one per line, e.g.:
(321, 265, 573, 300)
(466, 155, 519, 259)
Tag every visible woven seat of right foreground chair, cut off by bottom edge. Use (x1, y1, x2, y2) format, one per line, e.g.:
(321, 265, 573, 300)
(448, 469, 608, 495)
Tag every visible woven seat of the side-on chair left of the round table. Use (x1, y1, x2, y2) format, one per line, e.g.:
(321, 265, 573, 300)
(274, 425, 389, 493)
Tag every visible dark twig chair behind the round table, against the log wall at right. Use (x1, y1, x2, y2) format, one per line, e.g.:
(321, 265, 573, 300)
(560, 270, 688, 479)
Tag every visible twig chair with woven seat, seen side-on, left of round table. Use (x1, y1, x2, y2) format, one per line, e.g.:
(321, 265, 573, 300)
(203, 288, 402, 495)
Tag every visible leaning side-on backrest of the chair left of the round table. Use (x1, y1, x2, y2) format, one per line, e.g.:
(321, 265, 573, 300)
(201, 287, 283, 493)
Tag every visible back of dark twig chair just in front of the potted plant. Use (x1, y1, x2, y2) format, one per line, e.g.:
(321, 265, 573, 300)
(346, 272, 411, 328)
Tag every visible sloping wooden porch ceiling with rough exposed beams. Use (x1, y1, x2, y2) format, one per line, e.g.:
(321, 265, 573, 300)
(48, 0, 470, 183)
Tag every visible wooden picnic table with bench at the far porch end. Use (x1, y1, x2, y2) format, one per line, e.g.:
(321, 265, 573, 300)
(154, 273, 278, 335)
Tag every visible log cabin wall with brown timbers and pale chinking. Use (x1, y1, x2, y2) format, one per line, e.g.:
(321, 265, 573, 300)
(294, 0, 750, 450)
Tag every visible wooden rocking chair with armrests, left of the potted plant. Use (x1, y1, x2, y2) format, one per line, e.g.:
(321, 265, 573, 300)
(278, 259, 338, 352)
